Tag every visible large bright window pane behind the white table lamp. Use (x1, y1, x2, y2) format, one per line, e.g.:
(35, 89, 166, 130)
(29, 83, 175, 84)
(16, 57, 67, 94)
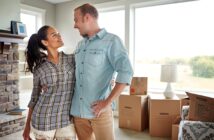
(134, 0, 214, 92)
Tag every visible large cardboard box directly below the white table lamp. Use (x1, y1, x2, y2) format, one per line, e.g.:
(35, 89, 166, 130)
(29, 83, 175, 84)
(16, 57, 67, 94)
(149, 97, 180, 137)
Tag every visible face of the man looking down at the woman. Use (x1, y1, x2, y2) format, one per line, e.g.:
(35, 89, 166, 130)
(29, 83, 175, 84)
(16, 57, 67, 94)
(74, 10, 87, 37)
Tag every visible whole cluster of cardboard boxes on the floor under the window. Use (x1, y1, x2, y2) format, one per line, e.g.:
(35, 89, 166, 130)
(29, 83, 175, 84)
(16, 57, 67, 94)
(119, 77, 191, 139)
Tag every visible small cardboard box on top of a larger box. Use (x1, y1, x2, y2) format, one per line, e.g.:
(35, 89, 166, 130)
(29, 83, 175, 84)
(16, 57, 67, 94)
(130, 77, 148, 95)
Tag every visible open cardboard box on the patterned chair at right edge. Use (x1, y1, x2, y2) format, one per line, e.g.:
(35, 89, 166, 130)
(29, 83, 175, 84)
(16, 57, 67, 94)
(187, 92, 214, 122)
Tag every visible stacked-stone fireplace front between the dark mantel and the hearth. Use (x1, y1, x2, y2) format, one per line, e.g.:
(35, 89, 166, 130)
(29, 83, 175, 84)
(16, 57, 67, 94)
(0, 42, 19, 113)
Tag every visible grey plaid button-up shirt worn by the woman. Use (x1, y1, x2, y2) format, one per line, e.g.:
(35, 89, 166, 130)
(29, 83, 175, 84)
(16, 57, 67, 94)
(28, 52, 75, 131)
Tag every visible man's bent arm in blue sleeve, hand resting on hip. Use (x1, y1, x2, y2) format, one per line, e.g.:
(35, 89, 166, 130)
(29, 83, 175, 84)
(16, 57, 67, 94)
(92, 36, 133, 117)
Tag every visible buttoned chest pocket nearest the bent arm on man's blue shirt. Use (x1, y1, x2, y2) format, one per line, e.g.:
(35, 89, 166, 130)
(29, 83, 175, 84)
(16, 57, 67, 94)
(85, 49, 104, 66)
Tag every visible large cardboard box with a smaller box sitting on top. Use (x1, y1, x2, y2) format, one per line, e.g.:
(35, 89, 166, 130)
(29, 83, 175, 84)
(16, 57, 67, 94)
(119, 95, 148, 131)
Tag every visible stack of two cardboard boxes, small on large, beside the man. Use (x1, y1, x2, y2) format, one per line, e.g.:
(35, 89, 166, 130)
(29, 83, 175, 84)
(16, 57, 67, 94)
(119, 77, 148, 131)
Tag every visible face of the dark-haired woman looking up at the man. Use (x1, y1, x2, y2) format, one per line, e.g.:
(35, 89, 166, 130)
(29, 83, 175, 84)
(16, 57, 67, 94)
(43, 27, 64, 49)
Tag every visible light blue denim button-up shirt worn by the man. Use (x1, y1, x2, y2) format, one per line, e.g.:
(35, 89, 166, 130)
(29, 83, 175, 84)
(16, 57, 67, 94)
(71, 29, 133, 119)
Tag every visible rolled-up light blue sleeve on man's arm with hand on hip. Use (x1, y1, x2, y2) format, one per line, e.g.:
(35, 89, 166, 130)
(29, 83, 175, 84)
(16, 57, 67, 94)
(108, 36, 133, 85)
